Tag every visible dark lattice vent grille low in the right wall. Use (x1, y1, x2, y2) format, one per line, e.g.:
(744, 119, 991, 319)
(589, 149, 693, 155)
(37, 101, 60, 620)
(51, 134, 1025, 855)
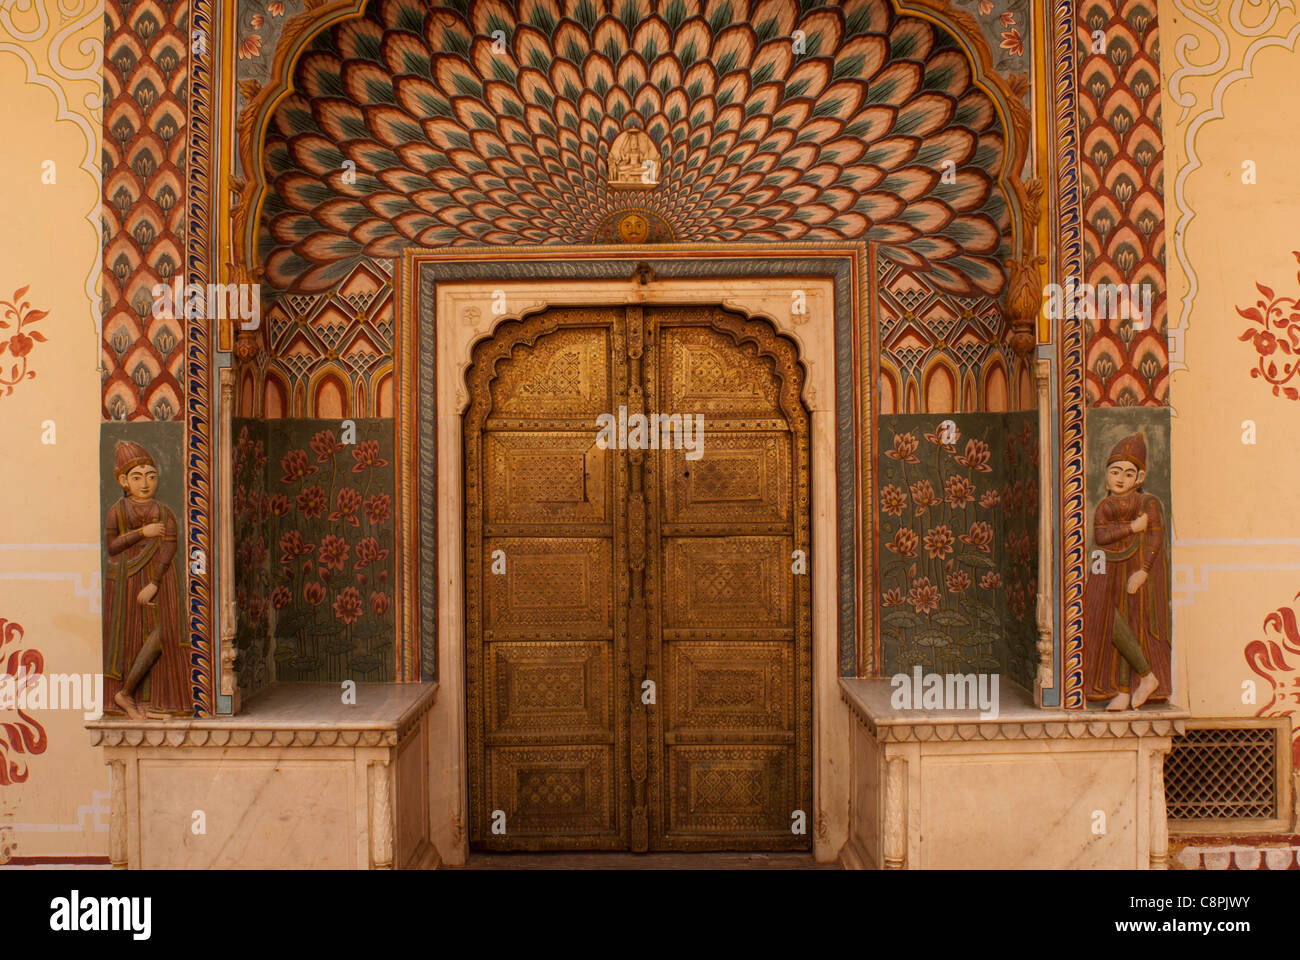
(1165, 727, 1279, 820)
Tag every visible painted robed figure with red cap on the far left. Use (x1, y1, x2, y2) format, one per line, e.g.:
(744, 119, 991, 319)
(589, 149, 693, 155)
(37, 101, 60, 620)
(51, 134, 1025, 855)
(104, 440, 192, 719)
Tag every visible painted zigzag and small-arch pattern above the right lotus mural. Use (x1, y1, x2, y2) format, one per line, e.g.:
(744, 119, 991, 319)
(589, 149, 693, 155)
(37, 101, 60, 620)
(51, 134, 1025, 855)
(876, 248, 1027, 414)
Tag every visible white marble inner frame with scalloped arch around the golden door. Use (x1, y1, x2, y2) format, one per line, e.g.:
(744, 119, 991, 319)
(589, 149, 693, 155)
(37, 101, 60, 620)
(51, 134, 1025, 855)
(429, 277, 849, 865)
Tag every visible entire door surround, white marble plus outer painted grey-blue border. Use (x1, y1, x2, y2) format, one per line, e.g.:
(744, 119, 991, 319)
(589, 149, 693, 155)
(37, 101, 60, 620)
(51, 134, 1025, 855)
(395, 243, 875, 865)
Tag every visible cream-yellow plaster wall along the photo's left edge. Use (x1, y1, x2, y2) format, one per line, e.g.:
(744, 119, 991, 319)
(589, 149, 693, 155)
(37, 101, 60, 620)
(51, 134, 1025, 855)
(0, 0, 109, 857)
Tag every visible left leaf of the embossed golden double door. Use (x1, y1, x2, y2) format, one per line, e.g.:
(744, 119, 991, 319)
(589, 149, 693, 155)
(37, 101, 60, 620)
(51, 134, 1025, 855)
(465, 310, 628, 849)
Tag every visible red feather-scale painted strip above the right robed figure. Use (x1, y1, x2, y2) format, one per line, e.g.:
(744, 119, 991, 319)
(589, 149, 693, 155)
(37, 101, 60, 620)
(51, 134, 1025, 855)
(1076, 0, 1169, 406)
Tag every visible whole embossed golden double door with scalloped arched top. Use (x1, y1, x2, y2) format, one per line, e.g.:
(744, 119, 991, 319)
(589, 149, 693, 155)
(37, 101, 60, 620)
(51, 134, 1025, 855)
(464, 307, 814, 851)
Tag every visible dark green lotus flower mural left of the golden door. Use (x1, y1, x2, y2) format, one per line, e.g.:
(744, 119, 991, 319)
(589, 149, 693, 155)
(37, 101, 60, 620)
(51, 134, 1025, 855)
(234, 419, 397, 691)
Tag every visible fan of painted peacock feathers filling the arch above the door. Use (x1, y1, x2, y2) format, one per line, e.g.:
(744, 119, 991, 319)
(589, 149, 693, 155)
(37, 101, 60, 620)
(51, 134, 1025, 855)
(259, 0, 1010, 295)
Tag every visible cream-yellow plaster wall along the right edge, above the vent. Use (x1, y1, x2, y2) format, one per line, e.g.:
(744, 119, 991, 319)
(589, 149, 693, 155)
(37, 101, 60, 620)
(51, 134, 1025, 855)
(1160, 0, 1300, 749)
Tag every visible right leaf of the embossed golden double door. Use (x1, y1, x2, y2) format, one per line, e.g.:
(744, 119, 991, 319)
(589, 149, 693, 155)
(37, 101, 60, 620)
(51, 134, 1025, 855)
(646, 307, 814, 849)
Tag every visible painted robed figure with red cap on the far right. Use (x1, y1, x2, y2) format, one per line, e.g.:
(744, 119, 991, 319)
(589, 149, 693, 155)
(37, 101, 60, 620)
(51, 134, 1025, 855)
(1083, 433, 1170, 710)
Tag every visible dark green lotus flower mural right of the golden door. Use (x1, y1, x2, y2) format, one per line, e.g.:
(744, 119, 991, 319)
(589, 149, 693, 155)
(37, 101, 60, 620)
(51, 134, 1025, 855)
(876, 411, 1039, 688)
